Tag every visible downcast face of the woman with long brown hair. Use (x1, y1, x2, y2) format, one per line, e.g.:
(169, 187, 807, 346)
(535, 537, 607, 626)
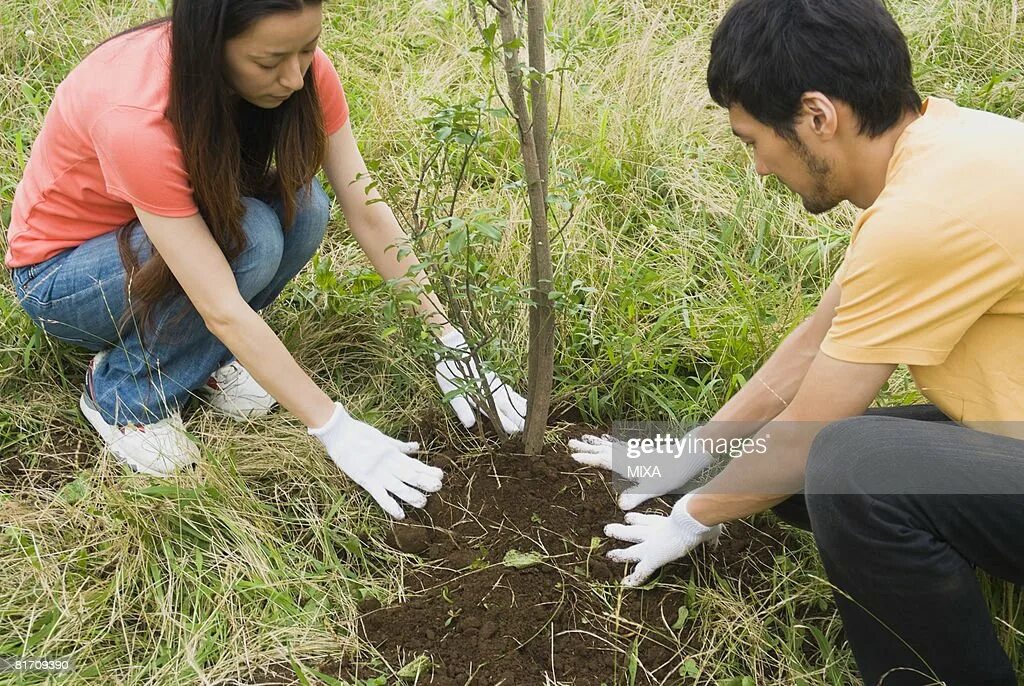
(224, 4, 324, 110)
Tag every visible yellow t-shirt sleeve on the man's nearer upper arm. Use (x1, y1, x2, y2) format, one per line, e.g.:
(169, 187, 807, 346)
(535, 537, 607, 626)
(821, 205, 1024, 366)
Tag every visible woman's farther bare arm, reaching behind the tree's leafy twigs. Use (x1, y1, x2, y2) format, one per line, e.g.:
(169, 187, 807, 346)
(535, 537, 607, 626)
(324, 122, 453, 336)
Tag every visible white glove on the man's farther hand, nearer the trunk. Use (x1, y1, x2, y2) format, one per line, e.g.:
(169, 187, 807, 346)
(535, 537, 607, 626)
(568, 427, 712, 510)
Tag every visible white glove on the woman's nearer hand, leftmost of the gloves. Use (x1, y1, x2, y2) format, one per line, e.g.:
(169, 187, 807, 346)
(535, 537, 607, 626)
(309, 402, 444, 519)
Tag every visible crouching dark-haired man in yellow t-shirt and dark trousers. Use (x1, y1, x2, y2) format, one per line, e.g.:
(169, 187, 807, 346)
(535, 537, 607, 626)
(573, 0, 1024, 686)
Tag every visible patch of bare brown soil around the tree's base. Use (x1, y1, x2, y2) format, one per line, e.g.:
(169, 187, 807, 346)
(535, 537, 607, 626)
(324, 430, 802, 686)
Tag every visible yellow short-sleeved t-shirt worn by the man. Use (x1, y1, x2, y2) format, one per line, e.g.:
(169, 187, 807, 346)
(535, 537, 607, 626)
(821, 98, 1024, 435)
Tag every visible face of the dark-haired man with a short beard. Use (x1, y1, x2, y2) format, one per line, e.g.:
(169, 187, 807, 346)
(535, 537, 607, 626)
(729, 104, 845, 214)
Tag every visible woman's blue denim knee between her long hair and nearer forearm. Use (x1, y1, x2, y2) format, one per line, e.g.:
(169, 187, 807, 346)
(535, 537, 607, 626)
(231, 198, 285, 299)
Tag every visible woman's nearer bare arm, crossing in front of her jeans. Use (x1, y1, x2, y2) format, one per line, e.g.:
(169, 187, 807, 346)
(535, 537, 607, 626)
(135, 208, 335, 428)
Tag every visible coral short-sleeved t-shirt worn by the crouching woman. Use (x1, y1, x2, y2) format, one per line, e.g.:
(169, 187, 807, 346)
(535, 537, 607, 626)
(4, 23, 348, 267)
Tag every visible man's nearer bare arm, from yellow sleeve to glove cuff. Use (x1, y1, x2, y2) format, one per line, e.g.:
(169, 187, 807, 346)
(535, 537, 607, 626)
(688, 352, 896, 526)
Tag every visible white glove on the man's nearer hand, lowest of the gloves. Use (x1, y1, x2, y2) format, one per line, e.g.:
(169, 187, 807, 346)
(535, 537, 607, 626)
(604, 494, 722, 587)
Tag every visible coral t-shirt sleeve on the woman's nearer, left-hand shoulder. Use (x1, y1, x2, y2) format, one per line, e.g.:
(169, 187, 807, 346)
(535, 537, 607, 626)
(91, 108, 199, 217)
